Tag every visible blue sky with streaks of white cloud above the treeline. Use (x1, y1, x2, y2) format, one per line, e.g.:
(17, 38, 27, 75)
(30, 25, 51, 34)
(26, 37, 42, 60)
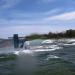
(0, 0, 75, 38)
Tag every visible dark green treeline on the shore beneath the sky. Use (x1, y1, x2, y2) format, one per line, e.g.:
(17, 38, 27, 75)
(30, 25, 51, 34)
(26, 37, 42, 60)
(25, 29, 75, 40)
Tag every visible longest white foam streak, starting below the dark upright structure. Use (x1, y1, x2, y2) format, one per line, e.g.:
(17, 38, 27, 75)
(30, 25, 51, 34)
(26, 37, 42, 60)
(14, 45, 62, 55)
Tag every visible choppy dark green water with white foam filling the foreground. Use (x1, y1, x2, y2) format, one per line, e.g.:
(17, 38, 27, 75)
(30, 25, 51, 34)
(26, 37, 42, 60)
(0, 40, 75, 75)
